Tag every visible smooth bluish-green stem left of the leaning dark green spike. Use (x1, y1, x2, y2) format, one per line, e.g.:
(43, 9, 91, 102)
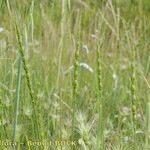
(13, 57, 21, 149)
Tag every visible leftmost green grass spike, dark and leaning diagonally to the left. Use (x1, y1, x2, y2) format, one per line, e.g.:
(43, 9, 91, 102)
(15, 25, 39, 139)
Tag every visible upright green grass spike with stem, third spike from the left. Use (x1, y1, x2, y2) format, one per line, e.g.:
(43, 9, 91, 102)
(97, 43, 104, 150)
